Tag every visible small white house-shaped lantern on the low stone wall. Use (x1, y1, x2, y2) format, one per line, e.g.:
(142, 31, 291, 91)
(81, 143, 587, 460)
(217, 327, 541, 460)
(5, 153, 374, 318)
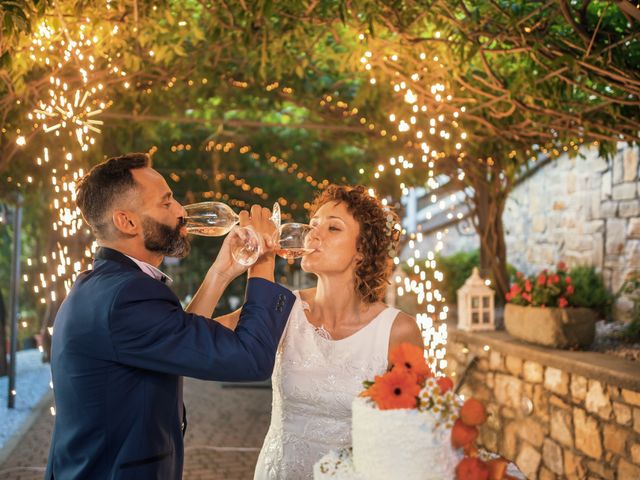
(458, 267, 496, 331)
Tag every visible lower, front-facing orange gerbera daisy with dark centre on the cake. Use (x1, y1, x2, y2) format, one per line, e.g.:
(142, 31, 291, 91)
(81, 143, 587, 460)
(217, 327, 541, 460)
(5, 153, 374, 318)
(369, 369, 420, 410)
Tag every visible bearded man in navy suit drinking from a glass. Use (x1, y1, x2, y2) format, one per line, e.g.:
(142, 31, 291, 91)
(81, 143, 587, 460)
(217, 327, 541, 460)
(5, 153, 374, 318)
(45, 154, 294, 480)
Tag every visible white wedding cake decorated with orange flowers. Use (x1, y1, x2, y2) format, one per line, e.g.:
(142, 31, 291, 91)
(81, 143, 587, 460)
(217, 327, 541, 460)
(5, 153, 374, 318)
(313, 344, 522, 480)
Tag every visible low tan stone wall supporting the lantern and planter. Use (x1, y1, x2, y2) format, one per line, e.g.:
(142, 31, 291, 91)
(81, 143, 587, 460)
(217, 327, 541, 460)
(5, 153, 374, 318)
(446, 328, 640, 480)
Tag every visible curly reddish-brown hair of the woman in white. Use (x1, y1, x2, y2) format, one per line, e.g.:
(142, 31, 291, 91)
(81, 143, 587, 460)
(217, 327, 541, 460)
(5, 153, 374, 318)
(310, 185, 400, 303)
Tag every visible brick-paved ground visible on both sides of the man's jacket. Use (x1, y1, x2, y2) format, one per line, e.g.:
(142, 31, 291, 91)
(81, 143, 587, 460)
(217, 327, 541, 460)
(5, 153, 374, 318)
(0, 379, 271, 480)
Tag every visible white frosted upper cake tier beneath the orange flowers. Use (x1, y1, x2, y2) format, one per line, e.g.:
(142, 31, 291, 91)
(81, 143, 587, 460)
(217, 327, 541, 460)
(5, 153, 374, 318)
(351, 397, 462, 480)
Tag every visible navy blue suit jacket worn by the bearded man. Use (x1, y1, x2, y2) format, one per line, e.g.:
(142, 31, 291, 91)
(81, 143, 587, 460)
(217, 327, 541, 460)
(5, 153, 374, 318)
(45, 248, 295, 480)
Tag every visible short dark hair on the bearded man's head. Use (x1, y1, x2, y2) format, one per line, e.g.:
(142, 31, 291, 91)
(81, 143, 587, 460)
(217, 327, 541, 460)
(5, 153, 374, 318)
(76, 153, 150, 239)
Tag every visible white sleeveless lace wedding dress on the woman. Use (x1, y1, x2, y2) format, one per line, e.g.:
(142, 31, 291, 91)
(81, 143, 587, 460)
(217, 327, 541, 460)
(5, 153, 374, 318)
(254, 292, 398, 480)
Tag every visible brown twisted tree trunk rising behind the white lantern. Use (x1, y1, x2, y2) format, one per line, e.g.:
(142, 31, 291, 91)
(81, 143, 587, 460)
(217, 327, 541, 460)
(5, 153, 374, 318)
(474, 178, 509, 305)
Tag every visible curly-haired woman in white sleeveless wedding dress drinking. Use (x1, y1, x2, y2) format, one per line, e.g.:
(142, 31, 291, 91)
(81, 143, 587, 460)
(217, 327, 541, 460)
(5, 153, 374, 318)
(218, 185, 423, 480)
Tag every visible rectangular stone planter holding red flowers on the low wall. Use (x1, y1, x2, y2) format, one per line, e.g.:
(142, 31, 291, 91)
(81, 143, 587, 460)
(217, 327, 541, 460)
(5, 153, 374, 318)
(504, 303, 598, 349)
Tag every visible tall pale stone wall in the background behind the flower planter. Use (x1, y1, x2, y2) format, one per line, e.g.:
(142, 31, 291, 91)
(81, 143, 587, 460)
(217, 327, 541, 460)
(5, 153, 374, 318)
(504, 145, 640, 316)
